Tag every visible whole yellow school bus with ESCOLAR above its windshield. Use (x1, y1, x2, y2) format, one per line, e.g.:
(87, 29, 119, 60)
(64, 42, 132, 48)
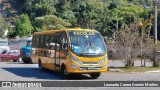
(31, 28, 108, 78)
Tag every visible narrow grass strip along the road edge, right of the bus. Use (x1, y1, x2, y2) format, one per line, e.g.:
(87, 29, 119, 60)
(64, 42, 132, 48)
(110, 67, 160, 72)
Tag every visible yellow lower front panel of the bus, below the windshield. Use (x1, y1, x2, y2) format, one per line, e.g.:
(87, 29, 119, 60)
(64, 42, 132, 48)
(66, 53, 108, 73)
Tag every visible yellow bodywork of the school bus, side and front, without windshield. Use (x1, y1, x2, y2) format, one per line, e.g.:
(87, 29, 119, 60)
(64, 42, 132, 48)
(31, 29, 108, 73)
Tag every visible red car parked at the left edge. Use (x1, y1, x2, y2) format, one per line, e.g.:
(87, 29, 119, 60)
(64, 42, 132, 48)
(0, 50, 20, 62)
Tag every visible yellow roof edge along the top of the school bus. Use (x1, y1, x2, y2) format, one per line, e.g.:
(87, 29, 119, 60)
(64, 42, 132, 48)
(34, 28, 96, 34)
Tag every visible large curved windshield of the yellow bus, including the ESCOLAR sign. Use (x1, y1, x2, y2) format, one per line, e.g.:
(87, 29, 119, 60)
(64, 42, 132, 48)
(69, 31, 106, 56)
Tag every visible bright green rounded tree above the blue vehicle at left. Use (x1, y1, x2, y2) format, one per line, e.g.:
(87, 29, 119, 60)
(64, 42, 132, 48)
(16, 14, 33, 37)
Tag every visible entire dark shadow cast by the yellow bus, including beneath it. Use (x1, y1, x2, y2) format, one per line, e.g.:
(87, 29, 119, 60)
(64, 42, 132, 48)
(2, 67, 95, 80)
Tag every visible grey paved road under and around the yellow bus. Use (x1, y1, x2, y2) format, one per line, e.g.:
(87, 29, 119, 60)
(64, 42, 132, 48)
(0, 62, 160, 90)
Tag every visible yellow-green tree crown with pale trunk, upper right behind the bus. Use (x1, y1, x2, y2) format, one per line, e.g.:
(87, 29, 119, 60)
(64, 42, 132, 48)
(109, 6, 144, 35)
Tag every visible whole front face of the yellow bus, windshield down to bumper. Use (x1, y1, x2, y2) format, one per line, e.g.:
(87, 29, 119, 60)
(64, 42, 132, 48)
(67, 30, 108, 78)
